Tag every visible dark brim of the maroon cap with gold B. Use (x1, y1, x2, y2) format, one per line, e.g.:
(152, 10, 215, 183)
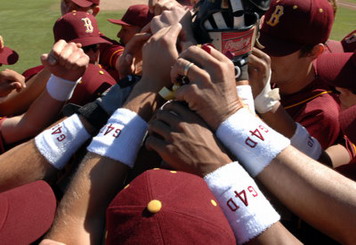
(258, 31, 303, 57)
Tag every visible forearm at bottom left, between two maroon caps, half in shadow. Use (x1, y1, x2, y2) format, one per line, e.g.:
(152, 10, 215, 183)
(47, 153, 127, 244)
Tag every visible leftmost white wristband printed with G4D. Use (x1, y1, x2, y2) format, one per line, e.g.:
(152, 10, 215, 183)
(35, 114, 90, 169)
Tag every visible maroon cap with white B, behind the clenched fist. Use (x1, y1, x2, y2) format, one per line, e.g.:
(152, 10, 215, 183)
(53, 11, 110, 47)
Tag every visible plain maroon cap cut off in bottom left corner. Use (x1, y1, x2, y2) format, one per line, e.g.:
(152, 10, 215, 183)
(0, 181, 56, 245)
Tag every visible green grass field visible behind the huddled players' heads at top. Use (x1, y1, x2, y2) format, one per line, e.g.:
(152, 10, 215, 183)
(0, 0, 356, 72)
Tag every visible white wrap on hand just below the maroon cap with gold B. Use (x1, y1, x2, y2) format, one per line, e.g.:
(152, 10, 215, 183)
(255, 71, 281, 113)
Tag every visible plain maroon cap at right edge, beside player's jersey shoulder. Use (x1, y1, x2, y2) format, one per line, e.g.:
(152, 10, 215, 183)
(316, 52, 356, 91)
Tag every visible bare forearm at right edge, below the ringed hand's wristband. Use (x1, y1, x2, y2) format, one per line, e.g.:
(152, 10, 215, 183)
(257, 147, 356, 244)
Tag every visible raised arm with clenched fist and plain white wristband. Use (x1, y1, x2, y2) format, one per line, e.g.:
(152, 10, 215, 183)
(2, 40, 89, 144)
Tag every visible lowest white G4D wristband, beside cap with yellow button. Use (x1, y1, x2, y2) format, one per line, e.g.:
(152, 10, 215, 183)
(204, 162, 280, 244)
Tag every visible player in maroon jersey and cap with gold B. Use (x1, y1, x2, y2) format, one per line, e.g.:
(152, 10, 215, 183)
(254, 0, 340, 149)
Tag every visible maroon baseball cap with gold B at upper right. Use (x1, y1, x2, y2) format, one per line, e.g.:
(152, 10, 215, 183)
(259, 0, 334, 56)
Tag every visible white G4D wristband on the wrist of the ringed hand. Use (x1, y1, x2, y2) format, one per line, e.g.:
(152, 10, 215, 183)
(216, 108, 290, 177)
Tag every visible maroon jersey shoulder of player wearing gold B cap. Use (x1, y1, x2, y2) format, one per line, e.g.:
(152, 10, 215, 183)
(281, 78, 340, 149)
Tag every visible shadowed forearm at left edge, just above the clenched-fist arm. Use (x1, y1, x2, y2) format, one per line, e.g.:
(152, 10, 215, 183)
(0, 68, 51, 116)
